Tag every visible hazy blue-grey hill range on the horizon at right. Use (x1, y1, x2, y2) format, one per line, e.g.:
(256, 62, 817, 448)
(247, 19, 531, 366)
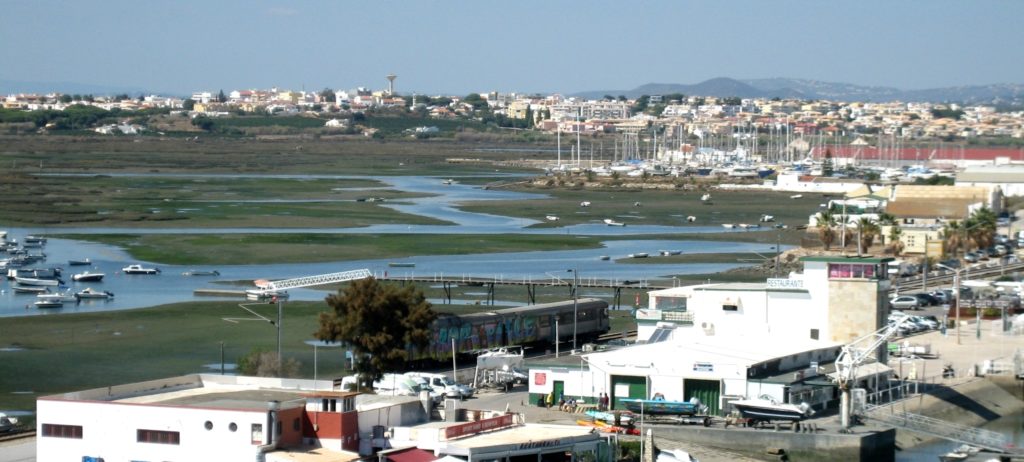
(572, 77, 1024, 104)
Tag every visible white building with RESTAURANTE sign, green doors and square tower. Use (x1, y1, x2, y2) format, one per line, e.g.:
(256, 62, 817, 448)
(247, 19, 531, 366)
(529, 256, 893, 413)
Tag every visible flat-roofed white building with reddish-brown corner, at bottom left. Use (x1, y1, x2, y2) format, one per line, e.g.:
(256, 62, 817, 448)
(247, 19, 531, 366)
(36, 374, 366, 462)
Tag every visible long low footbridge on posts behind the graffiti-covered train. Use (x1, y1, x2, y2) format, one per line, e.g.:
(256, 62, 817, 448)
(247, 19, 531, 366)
(376, 272, 671, 308)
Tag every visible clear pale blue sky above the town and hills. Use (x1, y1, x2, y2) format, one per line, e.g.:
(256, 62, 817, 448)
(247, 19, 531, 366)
(0, 0, 1024, 95)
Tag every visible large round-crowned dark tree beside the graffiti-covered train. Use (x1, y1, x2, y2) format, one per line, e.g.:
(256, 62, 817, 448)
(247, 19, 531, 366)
(314, 278, 437, 387)
